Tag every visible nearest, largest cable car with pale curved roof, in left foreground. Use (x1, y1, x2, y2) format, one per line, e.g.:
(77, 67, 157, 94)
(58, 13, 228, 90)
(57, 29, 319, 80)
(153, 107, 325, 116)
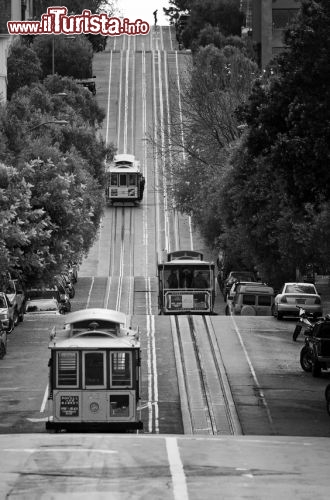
(46, 309, 143, 432)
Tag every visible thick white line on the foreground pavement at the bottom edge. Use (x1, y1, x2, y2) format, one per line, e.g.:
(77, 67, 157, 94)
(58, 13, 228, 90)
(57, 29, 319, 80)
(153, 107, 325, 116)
(166, 437, 188, 500)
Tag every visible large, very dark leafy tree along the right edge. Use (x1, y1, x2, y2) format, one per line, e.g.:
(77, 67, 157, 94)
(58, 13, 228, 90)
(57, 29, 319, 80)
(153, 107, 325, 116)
(221, 0, 330, 280)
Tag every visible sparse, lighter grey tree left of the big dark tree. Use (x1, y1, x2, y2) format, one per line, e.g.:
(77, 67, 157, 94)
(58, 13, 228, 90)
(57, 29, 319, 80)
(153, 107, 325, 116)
(152, 46, 258, 248)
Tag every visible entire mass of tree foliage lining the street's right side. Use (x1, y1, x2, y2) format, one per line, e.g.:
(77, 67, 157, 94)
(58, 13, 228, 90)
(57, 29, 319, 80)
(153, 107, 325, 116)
(165, 0, 330, 285)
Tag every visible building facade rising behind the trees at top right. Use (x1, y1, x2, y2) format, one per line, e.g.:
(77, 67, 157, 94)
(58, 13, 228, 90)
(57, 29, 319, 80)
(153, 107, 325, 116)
(251, 0, 301, 68)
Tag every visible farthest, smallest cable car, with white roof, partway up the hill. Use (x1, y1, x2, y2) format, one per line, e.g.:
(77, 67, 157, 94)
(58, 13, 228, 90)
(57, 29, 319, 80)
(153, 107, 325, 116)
(106, 154, 145, 205)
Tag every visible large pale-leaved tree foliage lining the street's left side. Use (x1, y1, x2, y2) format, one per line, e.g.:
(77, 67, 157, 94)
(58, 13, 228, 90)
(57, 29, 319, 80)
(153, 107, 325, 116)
(0, 75, 114, 283)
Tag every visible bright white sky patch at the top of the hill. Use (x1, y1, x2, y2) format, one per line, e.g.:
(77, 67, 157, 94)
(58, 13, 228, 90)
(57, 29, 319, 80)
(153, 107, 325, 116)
(117, 0, 169, 26)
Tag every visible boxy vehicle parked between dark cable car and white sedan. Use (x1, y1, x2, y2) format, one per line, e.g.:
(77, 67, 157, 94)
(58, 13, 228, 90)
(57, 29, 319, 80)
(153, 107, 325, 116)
(226, 283, 274, 316)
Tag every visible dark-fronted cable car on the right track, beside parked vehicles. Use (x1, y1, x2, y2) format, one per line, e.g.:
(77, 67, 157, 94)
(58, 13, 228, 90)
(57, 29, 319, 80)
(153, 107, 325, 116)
(158, 250, 215, 314)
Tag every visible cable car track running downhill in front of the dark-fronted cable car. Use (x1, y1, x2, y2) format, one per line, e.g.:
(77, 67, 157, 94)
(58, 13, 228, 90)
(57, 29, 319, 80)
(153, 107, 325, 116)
(171, 316, 242, 435)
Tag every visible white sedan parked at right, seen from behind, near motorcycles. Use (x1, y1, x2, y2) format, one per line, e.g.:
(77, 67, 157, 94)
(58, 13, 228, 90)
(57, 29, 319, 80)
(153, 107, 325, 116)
(273, 283, 323, 319)
